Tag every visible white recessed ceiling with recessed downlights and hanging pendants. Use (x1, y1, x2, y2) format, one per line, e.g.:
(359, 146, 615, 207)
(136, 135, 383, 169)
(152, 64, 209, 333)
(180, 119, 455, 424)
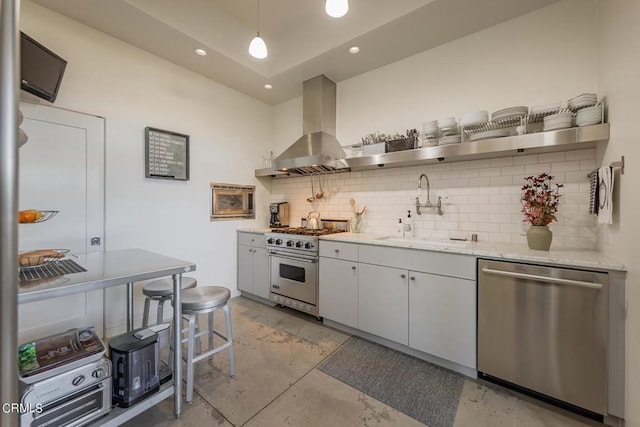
(34, 0, 558, 104)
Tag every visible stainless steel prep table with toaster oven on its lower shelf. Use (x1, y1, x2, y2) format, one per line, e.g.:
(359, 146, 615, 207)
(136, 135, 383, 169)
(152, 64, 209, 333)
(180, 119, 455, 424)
(18, 249, 196, 426)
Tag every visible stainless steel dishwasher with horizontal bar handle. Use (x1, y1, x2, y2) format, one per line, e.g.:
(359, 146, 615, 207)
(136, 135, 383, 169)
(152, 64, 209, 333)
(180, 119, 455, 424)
(478, 260, 608, 415)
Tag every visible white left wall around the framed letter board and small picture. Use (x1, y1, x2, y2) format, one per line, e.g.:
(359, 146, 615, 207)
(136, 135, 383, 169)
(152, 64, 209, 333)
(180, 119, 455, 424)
(21, 0, 273, 334)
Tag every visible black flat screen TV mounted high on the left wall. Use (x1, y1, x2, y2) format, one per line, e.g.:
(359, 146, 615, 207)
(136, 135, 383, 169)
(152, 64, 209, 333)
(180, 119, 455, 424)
(20, 32, 67, 102)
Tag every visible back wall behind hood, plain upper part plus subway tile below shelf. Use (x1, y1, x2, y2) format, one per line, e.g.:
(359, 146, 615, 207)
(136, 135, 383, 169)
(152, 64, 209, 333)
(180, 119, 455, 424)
(272, 0, 598, 248)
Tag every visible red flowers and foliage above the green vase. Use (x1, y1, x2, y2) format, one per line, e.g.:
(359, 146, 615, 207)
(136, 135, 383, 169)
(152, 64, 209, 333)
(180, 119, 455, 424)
(522, 173, 564, 226)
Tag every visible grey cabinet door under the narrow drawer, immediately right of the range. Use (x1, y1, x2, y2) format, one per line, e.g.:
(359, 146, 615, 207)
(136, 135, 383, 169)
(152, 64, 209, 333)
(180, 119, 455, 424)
(319, 258, 358, 328)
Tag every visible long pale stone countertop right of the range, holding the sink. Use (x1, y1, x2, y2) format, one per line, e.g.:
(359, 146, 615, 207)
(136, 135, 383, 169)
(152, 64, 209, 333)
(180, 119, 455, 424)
(320, 233, 627, 271)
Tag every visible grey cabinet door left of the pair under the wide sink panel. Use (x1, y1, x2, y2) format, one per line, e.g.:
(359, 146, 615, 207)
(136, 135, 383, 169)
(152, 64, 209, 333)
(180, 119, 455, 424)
(358, 263, 409, 345)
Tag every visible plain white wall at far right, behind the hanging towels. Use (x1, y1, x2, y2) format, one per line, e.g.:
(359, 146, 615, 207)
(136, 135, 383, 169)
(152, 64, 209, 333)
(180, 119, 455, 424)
(598, 0, 640, 426)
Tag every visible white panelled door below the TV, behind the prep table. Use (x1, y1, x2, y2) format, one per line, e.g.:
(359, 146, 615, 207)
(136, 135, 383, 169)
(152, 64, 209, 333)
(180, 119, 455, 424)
(18, 102, 104, 342)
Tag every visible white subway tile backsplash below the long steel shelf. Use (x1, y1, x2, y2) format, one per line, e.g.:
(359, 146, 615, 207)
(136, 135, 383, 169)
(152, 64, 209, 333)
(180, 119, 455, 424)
(270, 149, 599, 249)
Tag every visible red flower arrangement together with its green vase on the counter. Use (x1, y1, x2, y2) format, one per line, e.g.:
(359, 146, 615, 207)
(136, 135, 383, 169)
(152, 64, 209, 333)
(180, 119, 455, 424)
(521, 173, 564, 251)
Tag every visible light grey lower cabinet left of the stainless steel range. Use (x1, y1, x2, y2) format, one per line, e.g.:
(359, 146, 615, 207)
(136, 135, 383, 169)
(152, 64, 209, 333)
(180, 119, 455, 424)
(238, 232, 271, 299)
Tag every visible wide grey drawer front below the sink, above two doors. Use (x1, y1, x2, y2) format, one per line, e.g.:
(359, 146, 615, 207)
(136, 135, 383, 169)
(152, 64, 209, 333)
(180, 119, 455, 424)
(358, 245, 476, 280)
